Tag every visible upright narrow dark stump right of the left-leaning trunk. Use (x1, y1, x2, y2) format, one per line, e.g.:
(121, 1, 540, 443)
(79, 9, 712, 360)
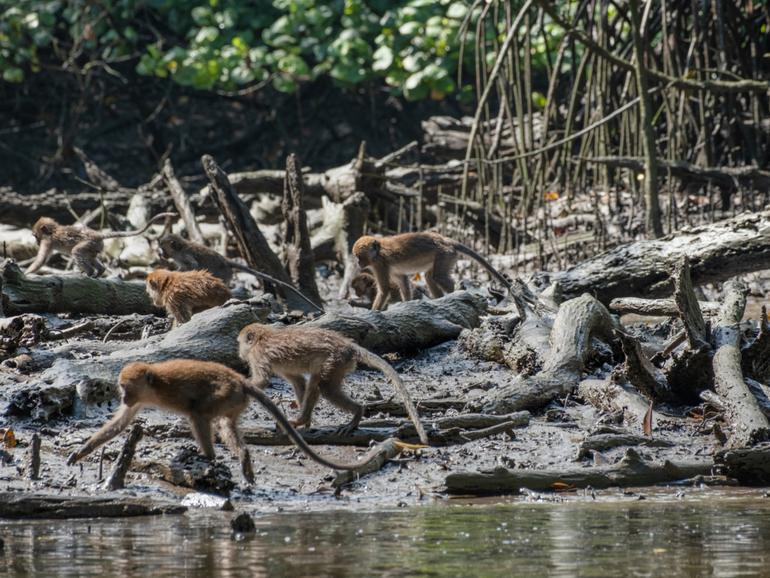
(281, 154, 321, 303)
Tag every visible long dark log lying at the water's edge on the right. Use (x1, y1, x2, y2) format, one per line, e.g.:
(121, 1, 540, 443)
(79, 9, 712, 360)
(445, 449, 713, 495)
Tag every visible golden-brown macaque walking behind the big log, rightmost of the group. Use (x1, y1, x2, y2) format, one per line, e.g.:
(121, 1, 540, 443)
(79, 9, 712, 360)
(353, 233, 511, 311)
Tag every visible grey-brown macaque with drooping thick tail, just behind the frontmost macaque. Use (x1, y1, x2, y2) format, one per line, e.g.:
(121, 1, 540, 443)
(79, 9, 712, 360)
(238, 323, 428, 445)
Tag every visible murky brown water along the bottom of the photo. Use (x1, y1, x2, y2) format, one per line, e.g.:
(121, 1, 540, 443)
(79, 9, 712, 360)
(0, 493, 770, 578)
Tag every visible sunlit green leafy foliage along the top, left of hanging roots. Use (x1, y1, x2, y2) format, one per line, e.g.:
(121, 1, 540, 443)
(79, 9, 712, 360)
(0, 0, 543, 99)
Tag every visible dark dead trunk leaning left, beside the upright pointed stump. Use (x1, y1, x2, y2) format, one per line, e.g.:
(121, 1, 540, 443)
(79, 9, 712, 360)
(201, 155, 310, 311)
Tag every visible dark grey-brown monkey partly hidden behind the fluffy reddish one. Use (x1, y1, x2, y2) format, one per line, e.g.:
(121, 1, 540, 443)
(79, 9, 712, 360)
(158, 233, 324, 313)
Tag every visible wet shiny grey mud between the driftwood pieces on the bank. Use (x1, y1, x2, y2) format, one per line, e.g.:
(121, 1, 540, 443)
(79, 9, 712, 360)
(0, 264, 732, 512)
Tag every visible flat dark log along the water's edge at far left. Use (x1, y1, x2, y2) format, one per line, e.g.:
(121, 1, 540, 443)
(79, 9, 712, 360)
(0, 492, 187, 520)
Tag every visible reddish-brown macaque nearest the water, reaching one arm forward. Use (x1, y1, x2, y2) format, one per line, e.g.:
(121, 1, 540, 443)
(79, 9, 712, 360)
(67, 359, 375, 483)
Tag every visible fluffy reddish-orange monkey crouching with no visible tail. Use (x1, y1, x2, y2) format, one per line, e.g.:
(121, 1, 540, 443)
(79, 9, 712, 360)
(146, 269, 230, 327)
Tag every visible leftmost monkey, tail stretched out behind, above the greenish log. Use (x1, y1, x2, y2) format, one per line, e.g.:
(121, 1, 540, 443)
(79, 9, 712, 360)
(25, 213, 175, 277)
